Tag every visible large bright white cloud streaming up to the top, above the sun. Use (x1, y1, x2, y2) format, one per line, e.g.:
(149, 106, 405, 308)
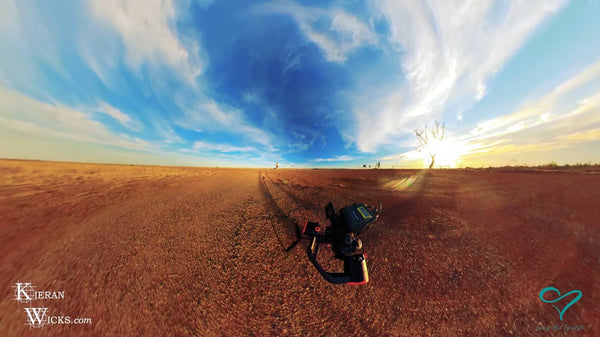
(352, 0, 565, 152)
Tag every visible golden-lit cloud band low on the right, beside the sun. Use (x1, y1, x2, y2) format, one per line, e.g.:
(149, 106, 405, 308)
(382, 56, 600, 165)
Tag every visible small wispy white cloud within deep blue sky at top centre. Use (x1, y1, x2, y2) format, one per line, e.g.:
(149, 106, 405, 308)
(259, 1, 377, 63)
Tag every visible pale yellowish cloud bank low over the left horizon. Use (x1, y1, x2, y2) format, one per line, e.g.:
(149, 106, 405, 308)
(0, 86, 274, 167)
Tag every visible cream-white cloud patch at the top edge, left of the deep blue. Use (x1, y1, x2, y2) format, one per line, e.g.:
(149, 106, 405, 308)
(86, 0, 203, 84)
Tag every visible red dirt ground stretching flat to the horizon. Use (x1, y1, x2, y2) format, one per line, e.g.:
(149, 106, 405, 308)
(0, 160, 600, 336)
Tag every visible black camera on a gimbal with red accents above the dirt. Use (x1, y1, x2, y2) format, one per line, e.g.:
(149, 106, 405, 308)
(302, 202, 381, 285)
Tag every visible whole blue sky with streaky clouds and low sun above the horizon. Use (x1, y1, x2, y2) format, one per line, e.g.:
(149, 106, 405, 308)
(0, 0, 600, 168)
